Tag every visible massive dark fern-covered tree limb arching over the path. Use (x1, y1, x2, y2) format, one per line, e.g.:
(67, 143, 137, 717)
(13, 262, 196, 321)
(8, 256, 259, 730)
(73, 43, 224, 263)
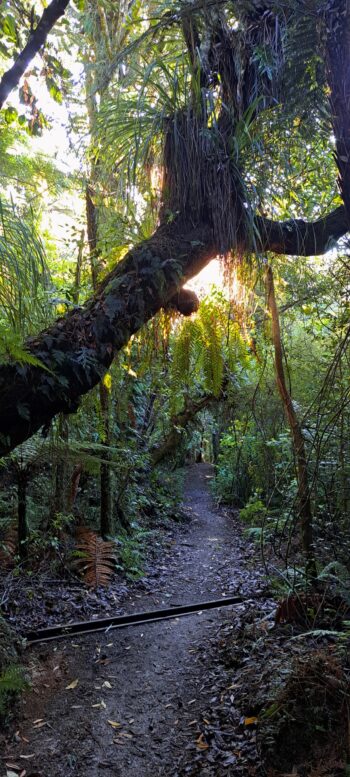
(0, 203, 347, 455)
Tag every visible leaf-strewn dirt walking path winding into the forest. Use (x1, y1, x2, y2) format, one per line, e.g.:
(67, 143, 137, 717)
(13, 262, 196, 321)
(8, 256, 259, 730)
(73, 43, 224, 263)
(0, 464, 261, 777)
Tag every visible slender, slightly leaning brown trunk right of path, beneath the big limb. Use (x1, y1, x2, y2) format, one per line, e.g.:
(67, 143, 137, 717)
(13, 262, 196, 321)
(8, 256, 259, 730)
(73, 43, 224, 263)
(266, 267, 317, 578)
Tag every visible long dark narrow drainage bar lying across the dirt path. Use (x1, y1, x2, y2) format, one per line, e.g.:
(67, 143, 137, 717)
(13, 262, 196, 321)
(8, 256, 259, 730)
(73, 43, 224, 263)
(23, 592, 269, 645)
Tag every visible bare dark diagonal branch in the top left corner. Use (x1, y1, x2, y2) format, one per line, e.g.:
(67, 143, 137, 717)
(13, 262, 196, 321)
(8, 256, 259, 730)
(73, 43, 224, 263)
(0, 0, 69, 108)
